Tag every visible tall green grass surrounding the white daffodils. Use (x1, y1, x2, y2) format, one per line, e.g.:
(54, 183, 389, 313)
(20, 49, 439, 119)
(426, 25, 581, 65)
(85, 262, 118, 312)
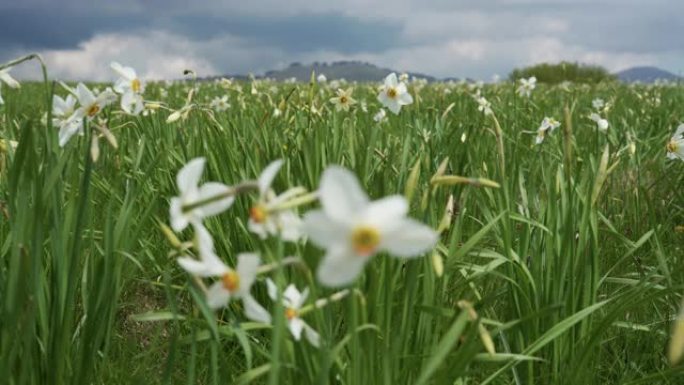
(0, 61, 684, 384)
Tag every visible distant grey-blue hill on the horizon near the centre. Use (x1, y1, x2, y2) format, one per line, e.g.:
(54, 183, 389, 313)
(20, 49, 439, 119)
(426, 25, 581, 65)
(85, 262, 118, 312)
(264, 61, 435, 82)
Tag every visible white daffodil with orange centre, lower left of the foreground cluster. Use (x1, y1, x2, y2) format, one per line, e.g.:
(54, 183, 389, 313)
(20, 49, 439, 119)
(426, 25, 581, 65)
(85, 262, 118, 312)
(178, 225, 271, 323)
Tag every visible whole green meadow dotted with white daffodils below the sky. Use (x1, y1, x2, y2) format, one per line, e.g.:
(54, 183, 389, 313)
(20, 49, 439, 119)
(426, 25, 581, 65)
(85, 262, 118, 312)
(0, 57, 684, 385)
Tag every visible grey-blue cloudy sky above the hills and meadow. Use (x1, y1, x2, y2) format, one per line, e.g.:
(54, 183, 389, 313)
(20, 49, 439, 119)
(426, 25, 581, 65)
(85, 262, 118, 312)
(0, 0, 684, 80)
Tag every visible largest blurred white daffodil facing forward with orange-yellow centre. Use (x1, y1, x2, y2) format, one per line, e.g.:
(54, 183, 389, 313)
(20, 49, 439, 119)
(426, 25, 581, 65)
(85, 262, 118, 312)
(304, 166, 437, 286)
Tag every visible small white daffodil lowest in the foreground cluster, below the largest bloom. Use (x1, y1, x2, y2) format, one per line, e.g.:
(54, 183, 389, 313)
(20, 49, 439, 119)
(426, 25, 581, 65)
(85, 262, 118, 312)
(266, 279, 321, 348)
